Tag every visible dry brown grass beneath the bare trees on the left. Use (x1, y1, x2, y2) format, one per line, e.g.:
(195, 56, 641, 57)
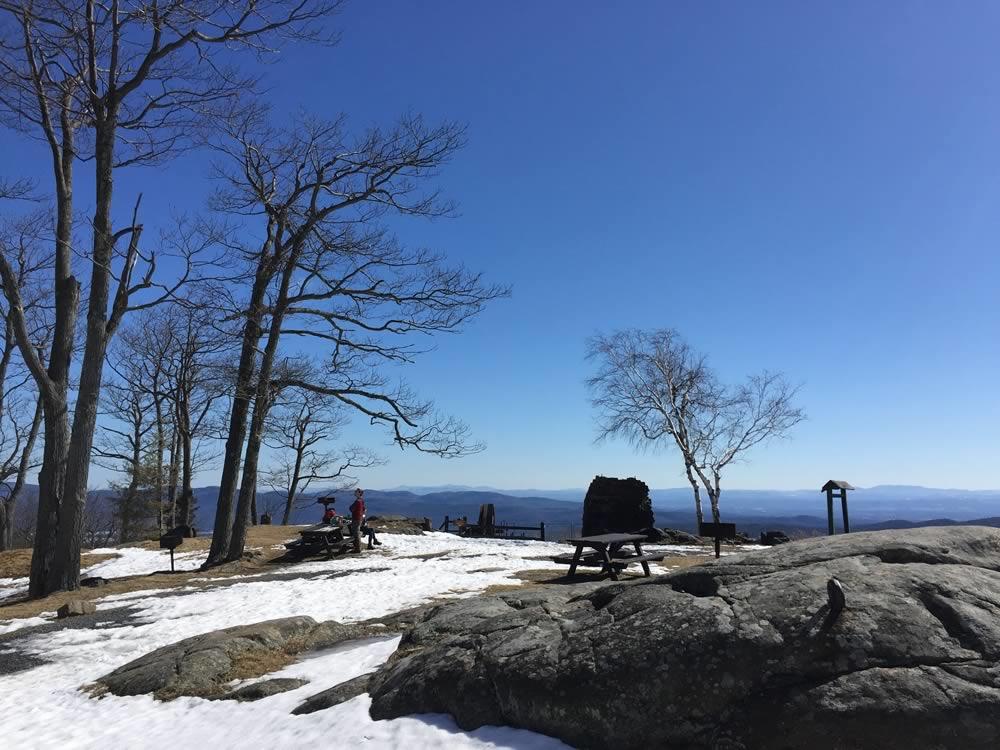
(0, 526, 300, 620)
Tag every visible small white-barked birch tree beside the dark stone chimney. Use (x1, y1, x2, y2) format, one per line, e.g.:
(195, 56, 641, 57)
(587, 329, 805, 525)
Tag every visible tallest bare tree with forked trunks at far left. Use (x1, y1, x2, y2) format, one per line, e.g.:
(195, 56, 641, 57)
(0, 0, 337, 596)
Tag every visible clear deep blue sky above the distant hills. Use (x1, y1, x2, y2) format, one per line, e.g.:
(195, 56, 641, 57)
(0, 1, 1000, 488)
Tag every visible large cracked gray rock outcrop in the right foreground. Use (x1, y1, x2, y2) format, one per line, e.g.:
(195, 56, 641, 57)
(369, 527, 1000, 750)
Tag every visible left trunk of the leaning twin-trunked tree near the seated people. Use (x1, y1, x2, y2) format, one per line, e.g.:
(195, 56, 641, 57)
(203, 261, 271, 567)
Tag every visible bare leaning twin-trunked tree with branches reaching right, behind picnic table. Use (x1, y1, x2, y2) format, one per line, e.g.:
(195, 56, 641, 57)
(206, 117, 507, 565)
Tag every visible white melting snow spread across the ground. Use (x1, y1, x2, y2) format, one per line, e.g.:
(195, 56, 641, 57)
(0, 533, 736, 750)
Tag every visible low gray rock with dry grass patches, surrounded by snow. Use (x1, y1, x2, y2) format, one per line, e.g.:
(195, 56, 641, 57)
(95, 617, 386, 700)
